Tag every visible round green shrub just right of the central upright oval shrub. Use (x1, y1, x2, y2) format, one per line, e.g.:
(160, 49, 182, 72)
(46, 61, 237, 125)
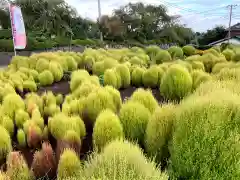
(119, 101, 150, 143)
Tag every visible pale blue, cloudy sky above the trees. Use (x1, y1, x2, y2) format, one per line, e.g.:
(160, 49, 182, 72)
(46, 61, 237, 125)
(66, 0, 240, 32)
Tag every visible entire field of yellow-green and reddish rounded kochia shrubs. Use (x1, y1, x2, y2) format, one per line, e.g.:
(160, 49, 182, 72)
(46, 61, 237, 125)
(0, 46, 240, 180)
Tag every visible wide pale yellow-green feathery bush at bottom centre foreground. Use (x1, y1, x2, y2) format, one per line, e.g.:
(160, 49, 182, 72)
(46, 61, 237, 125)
(82, 140, 168, 180)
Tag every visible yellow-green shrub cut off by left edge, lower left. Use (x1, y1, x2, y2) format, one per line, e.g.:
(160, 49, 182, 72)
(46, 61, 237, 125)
(0, 126, 12, 162)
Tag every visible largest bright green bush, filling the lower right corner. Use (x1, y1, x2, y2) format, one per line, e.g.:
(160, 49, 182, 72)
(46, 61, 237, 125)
(170, 90, 240, 180)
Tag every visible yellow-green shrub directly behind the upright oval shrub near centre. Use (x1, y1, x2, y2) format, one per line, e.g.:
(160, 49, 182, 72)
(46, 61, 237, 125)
(85, 88, 116, 124)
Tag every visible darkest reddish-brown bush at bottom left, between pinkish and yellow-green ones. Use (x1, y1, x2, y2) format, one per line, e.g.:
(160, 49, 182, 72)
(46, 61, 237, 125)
(31, 142, 57, 179)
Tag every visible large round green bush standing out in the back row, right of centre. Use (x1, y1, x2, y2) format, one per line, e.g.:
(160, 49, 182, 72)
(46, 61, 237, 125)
(160, 64, 193, 100)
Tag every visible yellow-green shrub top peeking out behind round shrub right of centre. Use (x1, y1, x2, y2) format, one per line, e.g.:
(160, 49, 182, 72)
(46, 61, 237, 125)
(130, 88, 158, 113)
